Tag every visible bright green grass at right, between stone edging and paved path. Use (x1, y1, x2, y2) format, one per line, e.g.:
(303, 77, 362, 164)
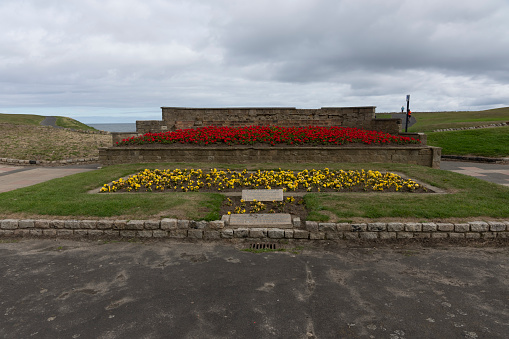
(428, 126, 509, 157)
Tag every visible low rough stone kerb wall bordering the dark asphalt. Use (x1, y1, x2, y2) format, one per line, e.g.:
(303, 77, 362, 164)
(0, 217, 509, 241)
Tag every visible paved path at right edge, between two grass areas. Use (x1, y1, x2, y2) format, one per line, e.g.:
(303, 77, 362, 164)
(440, 160, 509, 187)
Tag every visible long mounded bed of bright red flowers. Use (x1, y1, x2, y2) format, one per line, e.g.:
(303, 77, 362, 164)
(117, 126, 420, 146)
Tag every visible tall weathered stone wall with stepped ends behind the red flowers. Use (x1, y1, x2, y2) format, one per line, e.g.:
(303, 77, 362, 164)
(136, 106, 401, 134)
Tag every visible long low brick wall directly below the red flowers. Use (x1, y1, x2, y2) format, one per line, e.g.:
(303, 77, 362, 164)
(99, 145, 441, 168)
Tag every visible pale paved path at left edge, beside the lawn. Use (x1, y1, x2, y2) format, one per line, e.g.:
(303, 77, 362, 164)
(0, 164, 99, 193)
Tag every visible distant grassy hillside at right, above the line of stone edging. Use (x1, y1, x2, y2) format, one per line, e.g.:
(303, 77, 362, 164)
(408, 107, 509, 133)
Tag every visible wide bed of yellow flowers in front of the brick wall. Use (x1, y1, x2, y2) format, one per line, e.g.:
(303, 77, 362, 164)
(100, 168, 426, 192)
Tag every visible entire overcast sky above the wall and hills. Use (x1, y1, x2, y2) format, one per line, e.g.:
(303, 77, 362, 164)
(0, 0, 509, 123)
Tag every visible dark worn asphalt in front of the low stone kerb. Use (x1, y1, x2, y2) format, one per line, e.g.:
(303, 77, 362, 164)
(0, 239, 509, 339)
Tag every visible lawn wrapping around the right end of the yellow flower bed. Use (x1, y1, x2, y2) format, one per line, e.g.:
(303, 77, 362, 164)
(306, 165, 509, 221)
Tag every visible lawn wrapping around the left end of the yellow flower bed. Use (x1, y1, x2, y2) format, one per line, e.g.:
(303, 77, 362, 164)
(0, 165, 223, 220)
